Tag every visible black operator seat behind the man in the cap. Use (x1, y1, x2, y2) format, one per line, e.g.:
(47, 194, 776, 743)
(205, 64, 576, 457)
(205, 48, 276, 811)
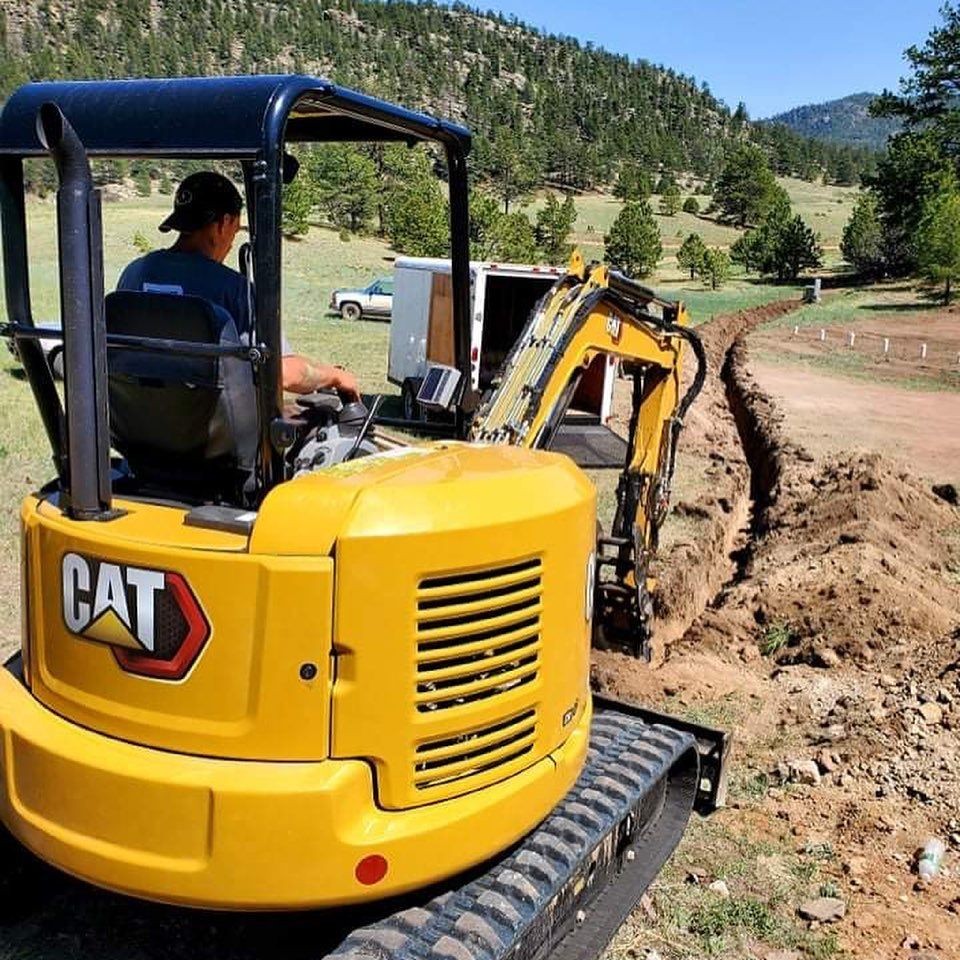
(105, 291, 258, 504)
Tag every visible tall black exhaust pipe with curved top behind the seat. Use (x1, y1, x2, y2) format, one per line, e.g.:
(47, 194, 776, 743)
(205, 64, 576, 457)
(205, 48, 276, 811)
(37, 102, 111, 520)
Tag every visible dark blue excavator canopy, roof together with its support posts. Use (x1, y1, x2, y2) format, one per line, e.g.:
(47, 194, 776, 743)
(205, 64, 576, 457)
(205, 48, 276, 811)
(0, 75, 470, 500)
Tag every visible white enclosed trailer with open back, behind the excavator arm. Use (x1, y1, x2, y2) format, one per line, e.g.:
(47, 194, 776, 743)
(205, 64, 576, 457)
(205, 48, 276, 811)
(387, 257, 616, 423)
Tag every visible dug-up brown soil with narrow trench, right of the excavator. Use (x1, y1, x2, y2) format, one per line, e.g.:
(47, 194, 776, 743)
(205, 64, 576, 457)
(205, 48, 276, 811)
(593, 303, 960, 960)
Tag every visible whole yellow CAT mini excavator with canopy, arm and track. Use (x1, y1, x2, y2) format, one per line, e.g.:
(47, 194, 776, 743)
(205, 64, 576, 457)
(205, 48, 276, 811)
(0, 76, 728, 960)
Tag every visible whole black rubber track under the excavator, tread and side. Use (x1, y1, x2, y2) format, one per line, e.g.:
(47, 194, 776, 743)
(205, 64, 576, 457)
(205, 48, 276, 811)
(328, 711, 698, 960)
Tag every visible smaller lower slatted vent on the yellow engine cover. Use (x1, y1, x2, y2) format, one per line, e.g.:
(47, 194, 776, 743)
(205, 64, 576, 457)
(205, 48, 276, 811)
(413, 708, 537, 790)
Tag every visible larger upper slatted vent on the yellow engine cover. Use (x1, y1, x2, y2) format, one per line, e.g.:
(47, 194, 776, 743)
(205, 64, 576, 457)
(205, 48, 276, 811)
(414, 558, 543, 713)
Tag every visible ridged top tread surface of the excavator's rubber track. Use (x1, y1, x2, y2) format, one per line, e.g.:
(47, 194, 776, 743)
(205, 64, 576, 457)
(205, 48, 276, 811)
(328, 711, 695, 960)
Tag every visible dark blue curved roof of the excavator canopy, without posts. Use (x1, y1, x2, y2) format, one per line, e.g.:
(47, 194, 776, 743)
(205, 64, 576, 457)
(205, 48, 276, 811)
(0, 74, 470, 157)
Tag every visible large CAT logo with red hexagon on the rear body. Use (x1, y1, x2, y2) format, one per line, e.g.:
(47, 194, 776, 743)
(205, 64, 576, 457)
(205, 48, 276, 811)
(61, 553, 210, 680)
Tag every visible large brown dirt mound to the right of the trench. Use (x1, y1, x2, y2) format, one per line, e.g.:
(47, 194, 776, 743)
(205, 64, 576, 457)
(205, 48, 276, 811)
(728, 454, 960, 662)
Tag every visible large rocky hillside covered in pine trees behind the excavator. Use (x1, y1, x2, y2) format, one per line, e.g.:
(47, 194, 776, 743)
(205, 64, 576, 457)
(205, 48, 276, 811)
(0, 0, 872, 189)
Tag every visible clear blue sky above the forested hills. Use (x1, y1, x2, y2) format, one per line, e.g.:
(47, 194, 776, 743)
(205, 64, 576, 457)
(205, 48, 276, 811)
(480, 0, 942, 118)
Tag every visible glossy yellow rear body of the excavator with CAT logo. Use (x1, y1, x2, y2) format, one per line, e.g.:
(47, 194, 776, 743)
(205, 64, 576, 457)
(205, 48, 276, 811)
(0, 442, 595, 908)
